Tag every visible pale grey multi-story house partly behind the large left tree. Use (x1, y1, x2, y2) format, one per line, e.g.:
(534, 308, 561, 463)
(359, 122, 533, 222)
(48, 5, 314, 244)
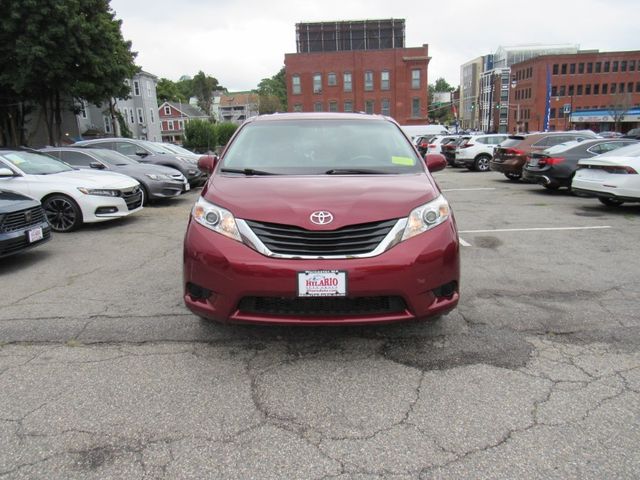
(77, 71, 161, 142)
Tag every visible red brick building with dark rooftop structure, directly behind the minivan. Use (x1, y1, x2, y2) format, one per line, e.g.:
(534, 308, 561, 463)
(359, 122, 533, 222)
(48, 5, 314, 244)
(285, 19, 429, 125)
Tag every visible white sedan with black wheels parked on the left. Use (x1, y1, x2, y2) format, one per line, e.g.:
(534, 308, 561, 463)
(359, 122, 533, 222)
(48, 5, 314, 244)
(0, 149, 142, 232)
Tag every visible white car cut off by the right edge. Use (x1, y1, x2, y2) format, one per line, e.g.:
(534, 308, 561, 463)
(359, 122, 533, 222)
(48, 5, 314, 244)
(571, 143, 640, 207)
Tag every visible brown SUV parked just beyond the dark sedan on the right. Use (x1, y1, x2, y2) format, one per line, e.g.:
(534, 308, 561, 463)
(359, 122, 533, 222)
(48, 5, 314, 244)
(491, 131, 597, 180)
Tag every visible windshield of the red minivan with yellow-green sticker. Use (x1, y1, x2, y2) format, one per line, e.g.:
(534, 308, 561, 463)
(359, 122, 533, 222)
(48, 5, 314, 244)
(222, 119, 424, 175)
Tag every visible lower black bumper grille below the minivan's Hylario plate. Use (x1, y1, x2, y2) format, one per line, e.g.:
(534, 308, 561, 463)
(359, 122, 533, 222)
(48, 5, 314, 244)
(238, 296, 407, 317)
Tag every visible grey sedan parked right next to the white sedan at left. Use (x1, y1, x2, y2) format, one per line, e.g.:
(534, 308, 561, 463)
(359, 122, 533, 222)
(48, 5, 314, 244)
(41, 147, 190, 204)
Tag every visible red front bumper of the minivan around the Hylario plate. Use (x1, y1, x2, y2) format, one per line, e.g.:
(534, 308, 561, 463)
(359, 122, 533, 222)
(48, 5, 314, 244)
(183, 220, 460, 325)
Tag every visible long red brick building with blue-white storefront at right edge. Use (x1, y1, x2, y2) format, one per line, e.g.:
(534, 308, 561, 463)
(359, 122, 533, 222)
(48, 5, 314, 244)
(508, 51, 640, 132)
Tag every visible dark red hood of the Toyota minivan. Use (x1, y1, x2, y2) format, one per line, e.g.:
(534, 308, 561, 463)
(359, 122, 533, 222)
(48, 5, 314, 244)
(202, 174, 440, 230)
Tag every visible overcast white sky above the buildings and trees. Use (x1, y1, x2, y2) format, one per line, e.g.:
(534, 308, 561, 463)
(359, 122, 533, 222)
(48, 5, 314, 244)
(111, 0, 640, 91)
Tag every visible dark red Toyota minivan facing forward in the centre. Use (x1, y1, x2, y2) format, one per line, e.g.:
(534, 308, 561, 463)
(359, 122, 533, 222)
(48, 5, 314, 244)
(183, 113, 460, 325)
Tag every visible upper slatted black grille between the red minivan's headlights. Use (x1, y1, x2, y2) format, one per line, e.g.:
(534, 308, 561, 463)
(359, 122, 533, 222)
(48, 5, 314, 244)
(246, 219, 397, 256)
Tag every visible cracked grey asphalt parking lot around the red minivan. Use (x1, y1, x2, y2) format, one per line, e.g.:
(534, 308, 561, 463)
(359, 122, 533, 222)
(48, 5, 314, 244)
(0, 168, 640, 480)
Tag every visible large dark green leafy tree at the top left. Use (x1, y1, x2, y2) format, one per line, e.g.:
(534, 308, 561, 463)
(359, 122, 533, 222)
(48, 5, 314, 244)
(0, 0, 137, 145)
